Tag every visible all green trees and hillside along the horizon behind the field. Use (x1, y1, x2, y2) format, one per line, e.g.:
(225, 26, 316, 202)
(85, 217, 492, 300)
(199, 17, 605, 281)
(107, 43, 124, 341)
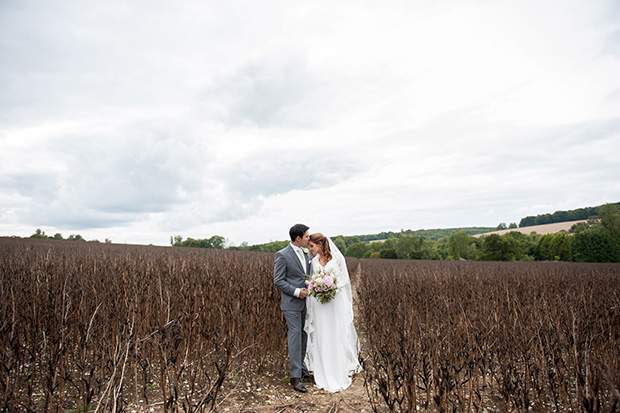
(30, 203, 620, 262)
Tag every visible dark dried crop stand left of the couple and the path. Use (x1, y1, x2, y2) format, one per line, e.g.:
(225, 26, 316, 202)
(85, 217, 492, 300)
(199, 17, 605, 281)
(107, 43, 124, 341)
(0, 238, 287, 411)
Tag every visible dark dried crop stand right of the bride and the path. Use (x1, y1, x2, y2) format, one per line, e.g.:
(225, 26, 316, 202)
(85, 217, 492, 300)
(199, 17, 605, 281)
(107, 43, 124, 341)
(357, 260, 620, 412)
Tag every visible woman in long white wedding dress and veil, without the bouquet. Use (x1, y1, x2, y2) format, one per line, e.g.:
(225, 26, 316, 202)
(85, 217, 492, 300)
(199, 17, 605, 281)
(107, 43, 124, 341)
(304, 233, 362, 392)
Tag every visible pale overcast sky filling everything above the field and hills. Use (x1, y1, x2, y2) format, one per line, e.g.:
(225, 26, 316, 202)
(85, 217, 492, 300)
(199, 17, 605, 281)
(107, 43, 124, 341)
(0, 0, 620, 245)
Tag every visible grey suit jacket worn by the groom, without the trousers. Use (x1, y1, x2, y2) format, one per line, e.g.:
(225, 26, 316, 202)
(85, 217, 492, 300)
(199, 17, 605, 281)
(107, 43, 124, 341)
(273, 244, 312, 311)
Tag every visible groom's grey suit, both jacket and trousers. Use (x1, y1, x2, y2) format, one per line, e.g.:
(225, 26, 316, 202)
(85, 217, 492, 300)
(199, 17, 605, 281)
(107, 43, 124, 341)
(273, 244, 312, 377)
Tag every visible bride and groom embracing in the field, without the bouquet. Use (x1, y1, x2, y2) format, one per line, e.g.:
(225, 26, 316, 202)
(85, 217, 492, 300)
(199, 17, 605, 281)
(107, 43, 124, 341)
(273, 224, 361, 393)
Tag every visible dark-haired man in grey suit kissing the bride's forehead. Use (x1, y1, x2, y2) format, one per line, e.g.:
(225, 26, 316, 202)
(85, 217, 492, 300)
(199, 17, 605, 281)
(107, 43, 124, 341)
(273, 224, 312, 393)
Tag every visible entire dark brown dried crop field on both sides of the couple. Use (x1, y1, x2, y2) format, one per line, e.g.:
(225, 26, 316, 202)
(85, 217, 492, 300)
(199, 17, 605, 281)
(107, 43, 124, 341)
(0, 238, 620, 412)
